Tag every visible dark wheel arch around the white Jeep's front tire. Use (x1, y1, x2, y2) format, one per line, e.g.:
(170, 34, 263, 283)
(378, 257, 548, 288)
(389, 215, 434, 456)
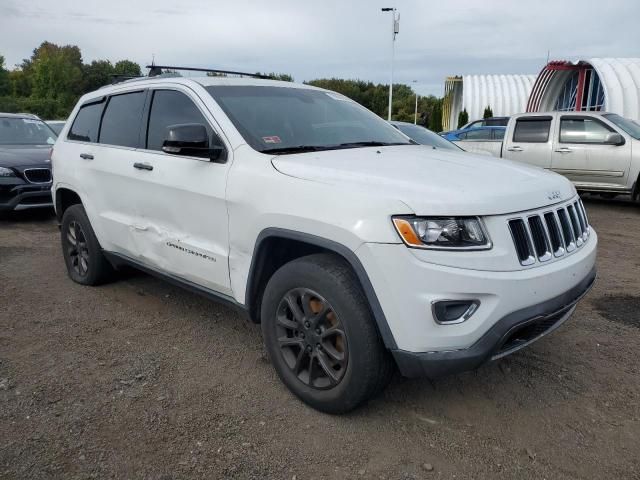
(245, 228, 397, 349)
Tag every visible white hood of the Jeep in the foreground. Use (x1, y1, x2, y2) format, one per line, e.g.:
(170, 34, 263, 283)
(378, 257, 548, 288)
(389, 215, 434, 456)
(272, 145, 576, 215)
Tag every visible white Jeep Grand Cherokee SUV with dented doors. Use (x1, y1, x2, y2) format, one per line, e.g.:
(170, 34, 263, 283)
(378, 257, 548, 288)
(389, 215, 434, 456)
(53, 76, 597, 413)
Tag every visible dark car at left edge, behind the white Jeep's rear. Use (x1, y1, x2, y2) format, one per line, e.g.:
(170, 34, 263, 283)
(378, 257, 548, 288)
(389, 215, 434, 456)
(0, 113, 56, 212)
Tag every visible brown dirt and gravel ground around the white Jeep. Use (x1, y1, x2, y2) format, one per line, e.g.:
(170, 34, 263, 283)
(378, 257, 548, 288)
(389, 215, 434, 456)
(0, 196, 640, 480)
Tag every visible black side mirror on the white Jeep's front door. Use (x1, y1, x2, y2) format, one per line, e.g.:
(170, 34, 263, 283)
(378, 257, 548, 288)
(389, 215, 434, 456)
(162, 123, 226, 162)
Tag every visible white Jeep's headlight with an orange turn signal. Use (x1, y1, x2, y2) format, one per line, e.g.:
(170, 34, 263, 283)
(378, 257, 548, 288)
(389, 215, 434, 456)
(393, 217, 491, 250)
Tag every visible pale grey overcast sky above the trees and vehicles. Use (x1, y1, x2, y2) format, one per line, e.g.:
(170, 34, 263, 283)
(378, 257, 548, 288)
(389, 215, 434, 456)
(0, 0, 640, 95)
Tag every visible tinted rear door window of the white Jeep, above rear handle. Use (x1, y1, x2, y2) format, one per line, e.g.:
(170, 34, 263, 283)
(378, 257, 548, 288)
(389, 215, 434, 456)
(100, 91, 146, 148)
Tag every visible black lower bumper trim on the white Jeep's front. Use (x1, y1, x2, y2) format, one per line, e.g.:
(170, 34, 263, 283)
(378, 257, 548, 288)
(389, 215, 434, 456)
(391, 267, 596, 378)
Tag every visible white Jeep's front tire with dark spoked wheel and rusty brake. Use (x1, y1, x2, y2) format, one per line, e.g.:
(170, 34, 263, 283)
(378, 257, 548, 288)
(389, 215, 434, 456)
(261, 254, 395, 414)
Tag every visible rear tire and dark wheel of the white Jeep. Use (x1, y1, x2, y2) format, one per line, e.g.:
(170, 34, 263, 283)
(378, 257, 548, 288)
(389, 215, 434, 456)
(60, 204, 114, 285)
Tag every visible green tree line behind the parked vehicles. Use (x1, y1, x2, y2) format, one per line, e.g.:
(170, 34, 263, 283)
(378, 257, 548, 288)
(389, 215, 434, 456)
(0, 42, 442, 132)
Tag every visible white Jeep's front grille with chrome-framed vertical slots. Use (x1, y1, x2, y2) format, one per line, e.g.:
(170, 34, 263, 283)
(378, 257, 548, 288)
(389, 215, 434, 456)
(509, 200, 590, 266)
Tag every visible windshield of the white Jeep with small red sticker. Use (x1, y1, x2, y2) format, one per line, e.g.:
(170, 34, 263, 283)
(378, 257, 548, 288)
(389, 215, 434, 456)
(207, 85, 411, 154)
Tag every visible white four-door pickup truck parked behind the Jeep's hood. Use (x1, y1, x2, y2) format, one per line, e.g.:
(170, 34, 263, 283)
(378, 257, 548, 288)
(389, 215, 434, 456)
(454, 112, 640, 200)
